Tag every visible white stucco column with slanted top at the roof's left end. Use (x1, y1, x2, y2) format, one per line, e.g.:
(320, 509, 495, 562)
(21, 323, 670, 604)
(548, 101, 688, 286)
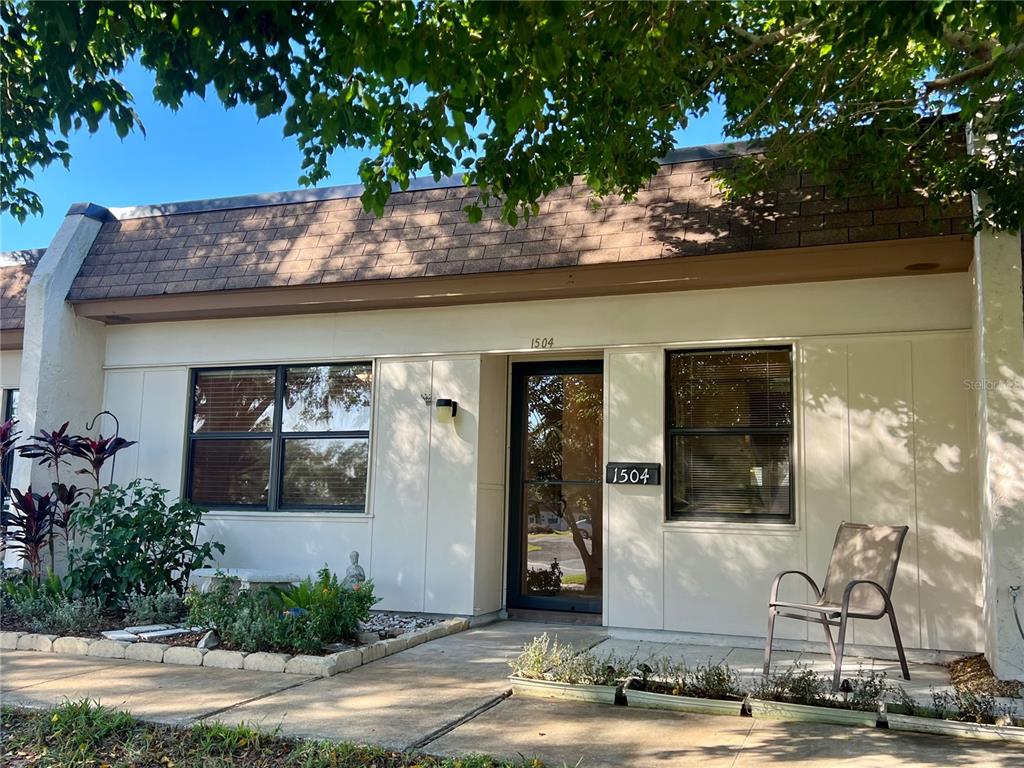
(12, 204, 106, 499)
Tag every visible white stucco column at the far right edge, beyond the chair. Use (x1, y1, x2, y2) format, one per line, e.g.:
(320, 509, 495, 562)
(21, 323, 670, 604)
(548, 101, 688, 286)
(970, 228, 1024, 680)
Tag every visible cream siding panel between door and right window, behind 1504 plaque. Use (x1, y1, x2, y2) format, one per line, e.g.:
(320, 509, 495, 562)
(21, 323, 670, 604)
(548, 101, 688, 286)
(604, 348, 663, 629)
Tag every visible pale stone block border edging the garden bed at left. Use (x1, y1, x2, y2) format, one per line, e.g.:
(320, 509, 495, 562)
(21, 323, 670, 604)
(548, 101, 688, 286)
(0, 618, 469, 677)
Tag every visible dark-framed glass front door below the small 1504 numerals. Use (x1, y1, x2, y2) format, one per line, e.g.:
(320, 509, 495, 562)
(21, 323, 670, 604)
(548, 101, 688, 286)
(508, 360, 604, 613)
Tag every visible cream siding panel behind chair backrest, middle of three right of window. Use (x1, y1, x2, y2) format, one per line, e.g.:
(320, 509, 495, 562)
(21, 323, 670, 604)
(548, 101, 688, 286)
(849, 339, 921, 647)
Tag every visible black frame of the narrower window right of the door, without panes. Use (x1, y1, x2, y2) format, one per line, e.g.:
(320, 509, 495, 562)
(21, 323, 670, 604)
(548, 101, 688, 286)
(665, 344, 797, 525)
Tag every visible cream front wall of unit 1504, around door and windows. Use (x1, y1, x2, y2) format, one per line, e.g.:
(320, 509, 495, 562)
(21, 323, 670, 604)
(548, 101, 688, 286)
(97, 274, 980, 648)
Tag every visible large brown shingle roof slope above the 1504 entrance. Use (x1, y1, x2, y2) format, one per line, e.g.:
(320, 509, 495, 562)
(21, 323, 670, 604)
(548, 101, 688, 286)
(68, 159, 970, 301)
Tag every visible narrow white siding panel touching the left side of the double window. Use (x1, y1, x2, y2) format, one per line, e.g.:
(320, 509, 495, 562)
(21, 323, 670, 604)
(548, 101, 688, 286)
(135, 369, 189, 499)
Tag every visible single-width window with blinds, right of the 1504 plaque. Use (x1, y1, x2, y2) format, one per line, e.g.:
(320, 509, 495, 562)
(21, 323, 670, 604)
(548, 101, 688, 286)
(667, 347, 794, 522)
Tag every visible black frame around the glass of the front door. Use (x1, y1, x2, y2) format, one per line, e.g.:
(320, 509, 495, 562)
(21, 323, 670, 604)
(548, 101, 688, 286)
(505, 357, 604, 615)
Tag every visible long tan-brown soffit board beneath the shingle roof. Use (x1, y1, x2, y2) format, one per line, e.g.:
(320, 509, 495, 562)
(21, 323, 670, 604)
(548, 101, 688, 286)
(73, 234, 972, 324)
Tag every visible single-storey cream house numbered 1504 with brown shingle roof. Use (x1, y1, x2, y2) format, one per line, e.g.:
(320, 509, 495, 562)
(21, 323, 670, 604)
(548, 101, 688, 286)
(3, 146, 1024, 678)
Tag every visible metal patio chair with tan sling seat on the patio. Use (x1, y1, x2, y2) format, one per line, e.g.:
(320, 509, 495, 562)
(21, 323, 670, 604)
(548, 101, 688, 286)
(765, 522, 910, 692)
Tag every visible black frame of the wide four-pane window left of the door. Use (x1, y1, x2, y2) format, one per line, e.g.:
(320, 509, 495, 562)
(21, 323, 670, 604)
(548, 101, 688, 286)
(183, 360, 376, 514)
